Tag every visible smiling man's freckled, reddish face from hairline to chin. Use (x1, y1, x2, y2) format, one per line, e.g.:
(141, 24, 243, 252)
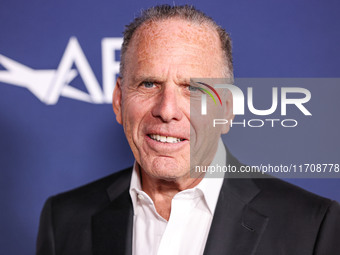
(113, 19, 232, 180)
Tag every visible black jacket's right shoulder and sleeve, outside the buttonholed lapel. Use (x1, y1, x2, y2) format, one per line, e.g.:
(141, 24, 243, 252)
(250, 178, 340, 255)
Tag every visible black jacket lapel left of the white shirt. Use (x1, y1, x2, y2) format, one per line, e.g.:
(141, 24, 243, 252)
(92, 169, 133, 255)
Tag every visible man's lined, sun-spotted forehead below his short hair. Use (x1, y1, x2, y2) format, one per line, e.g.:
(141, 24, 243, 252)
(125, 18, 224, 74)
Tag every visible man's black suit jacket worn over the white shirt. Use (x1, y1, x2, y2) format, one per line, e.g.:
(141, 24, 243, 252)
(37, 150, 340, 255)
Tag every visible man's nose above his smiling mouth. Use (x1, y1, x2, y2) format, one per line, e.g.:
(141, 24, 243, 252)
(152, 84, 183, 122)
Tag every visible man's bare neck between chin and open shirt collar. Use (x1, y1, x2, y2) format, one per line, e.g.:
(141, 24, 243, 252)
(140, 169, 203, 220)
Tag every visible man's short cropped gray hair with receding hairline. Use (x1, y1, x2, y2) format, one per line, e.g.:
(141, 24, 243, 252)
(120, 5, 233, 79)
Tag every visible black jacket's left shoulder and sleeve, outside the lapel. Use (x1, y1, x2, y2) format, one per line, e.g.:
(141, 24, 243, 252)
(37, 168, 132, 255)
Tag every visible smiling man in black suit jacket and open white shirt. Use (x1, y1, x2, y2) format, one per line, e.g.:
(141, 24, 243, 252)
(37, 6, 340, 255)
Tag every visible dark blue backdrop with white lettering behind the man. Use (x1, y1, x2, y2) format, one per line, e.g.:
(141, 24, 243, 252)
(0, 0, 340, 254)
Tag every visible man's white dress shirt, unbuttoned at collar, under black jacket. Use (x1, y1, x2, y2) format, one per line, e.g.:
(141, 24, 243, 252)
(130, 140, 226, 255)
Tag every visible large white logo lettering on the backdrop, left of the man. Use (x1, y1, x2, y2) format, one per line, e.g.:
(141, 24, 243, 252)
(0, 37, 123, 105)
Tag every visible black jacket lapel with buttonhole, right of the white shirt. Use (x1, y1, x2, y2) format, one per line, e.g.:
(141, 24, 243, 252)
(204, 152, 268, 255)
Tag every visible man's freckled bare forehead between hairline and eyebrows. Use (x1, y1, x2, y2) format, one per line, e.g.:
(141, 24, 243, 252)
(125, 19, 223, 78)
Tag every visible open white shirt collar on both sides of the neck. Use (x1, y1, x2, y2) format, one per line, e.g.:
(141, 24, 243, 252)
(129, 138, 227, 215)
